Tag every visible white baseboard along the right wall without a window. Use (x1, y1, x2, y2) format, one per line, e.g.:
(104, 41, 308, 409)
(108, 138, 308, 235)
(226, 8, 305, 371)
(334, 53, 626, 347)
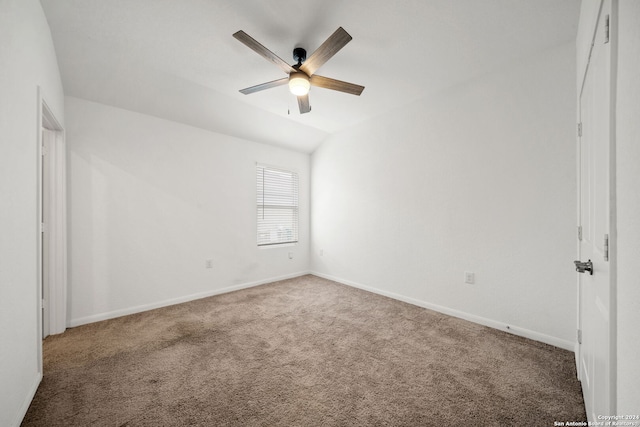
(311, 271, 575, 352)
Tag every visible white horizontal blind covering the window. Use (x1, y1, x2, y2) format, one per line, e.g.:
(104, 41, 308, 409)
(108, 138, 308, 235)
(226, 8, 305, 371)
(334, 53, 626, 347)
(256, 165, 298, 246)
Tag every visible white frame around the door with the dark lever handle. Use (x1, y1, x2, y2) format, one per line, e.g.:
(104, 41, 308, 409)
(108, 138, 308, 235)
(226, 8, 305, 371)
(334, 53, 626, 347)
(575, 0, 618, 421)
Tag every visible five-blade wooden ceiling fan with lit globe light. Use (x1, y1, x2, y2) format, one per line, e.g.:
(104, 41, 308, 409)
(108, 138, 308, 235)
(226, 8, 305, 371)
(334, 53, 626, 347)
(233, 27, 364, 114)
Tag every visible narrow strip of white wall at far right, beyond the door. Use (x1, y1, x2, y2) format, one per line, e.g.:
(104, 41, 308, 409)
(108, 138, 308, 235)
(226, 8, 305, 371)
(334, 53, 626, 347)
(616, 0, 640, 415)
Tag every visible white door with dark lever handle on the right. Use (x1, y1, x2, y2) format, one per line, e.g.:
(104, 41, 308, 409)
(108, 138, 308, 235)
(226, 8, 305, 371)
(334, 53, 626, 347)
(578, 0, 615, 421)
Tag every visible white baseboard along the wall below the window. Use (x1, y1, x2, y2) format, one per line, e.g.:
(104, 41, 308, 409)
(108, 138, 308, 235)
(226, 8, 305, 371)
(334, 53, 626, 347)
(68, 271, 310, 328)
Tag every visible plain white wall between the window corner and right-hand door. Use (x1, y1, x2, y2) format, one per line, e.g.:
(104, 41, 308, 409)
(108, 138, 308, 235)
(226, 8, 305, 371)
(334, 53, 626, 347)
(311, 44, 576, 350)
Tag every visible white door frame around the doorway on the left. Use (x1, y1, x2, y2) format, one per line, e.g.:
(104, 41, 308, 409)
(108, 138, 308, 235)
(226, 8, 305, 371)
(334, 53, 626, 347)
(36, 87, 67, 372)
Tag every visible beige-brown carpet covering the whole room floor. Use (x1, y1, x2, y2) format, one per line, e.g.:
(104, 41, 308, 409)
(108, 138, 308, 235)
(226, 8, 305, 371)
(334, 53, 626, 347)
(23, 276, 586, 427)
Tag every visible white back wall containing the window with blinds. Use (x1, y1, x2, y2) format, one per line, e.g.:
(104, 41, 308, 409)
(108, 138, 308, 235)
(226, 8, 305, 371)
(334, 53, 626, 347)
(65, 97, 310, 325)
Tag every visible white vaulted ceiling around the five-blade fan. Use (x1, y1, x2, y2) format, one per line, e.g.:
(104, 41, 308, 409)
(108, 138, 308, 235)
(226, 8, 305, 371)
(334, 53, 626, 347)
(41, 0, 580, 153)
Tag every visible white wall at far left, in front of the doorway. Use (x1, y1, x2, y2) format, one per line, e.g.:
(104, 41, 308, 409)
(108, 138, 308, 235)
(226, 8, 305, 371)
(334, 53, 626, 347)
(0, 0, 64, 426)
